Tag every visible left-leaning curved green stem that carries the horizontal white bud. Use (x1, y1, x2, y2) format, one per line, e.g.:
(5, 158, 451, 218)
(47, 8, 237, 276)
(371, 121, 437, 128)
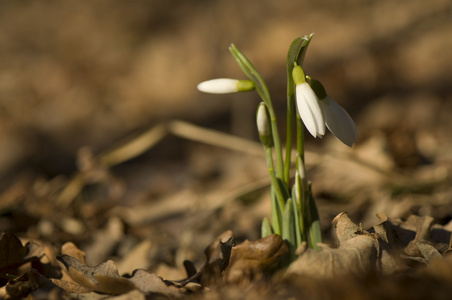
(229, 44, 284, 179)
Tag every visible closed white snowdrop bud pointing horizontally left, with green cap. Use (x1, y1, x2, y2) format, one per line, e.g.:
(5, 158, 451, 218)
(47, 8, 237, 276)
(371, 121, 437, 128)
(198, 78, 254, 94)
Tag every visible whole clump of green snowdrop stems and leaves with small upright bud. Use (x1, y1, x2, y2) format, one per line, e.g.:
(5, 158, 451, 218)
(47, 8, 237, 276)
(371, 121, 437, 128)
(229, 34, 321, 258)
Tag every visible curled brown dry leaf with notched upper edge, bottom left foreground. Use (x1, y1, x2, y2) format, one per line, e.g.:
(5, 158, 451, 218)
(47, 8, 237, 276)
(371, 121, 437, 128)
(53, 254, 136, 295)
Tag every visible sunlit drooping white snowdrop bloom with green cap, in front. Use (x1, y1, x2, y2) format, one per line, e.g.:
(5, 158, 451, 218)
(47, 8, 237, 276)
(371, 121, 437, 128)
(292, 65, 325, 137)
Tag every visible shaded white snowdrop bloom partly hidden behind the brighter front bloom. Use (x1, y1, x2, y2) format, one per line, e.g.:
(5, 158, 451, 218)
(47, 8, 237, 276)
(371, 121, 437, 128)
(311, 79, 358, 147)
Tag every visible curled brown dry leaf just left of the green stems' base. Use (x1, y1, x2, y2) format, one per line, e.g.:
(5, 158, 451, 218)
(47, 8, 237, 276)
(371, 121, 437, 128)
(224, 234, 289, 283)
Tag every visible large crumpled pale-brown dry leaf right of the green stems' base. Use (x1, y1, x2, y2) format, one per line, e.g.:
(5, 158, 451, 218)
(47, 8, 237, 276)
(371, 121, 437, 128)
(288, 213, 450, 278)
